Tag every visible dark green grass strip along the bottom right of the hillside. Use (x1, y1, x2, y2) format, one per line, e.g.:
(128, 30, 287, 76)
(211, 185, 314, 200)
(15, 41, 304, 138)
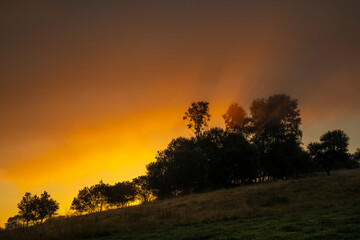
(100, 204, 360, 240)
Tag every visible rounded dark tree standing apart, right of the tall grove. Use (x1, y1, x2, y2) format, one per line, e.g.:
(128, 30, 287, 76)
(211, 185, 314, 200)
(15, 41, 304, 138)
(308, 130, 349, 175)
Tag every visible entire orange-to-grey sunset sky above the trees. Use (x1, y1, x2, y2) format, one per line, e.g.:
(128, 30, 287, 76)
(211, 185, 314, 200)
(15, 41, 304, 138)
(0, 0, 360, 224)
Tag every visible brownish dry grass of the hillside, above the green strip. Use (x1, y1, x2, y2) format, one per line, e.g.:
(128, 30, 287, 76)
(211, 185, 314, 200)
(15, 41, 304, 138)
(0, 170, 360, 239)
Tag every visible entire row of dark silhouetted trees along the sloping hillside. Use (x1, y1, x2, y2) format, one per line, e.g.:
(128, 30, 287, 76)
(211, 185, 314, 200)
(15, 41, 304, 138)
(6, 94, 360, 228)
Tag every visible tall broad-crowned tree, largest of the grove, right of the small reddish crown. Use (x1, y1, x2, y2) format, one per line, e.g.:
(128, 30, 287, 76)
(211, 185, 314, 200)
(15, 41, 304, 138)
(246, 94, 305, 178)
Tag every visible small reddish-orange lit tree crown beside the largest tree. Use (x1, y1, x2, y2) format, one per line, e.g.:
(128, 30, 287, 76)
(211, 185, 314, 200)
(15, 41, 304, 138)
(222, 103, 247, 132)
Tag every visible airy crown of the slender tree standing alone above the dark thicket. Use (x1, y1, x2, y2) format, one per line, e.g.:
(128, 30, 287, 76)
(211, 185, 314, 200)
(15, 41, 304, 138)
(183, 101, 211, 138)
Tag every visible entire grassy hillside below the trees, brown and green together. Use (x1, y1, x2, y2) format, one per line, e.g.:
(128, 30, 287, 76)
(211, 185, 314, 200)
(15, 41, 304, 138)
(0, 169, 360, 240)
